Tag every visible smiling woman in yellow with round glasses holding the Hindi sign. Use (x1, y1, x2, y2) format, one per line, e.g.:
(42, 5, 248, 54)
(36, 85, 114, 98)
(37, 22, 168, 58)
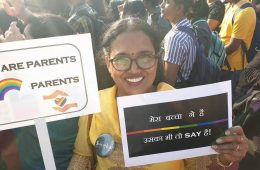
(68, 18, 247, 170)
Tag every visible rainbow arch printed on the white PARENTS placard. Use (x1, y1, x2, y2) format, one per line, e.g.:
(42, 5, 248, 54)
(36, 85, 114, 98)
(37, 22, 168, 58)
(0, 78, 22, 101)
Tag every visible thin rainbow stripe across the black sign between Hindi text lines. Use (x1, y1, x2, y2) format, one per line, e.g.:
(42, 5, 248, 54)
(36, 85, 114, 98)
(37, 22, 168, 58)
(127, 119, 228, 135)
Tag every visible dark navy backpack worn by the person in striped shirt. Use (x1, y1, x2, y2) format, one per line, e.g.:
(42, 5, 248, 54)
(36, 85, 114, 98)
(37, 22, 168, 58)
(178, 26, 221, 87)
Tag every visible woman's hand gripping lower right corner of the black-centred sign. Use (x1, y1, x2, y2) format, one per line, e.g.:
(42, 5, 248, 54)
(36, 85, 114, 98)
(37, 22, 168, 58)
(212, 126, 248, 164)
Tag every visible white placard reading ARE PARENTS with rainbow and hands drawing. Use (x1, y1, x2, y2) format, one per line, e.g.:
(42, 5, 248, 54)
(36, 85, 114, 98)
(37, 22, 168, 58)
(0, 34, 100, 130)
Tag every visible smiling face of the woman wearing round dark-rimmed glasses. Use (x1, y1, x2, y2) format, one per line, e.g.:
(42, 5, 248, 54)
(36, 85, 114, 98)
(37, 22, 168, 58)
(106, 31, 157, 96)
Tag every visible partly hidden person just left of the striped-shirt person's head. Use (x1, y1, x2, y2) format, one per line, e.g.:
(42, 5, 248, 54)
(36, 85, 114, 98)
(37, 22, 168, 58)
(143, 0, 171, 40)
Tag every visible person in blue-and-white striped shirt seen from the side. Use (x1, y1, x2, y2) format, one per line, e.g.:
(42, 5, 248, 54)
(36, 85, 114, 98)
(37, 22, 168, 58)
(161, 0, 196, 87)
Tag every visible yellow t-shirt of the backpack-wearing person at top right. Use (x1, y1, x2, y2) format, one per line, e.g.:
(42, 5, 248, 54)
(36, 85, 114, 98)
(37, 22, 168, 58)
(219, 0, 256, 71)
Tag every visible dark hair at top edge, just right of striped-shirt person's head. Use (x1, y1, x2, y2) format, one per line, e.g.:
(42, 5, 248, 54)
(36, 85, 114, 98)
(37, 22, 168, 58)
(187, 0, 209, 20)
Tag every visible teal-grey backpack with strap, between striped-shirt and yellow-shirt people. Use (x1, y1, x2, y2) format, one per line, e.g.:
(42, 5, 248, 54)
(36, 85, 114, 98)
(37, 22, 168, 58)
(193, 19, 227, 69)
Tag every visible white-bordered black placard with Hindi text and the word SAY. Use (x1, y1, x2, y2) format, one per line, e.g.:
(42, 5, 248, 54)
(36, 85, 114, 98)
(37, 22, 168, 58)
(117, 81, 232, 167)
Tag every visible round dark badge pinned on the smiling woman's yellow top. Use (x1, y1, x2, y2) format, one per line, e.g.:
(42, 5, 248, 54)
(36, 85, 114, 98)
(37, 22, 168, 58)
(95, 133, 116, 157)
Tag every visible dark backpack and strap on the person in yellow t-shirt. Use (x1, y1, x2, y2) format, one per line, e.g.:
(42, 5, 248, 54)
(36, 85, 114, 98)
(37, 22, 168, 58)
(232, 3, 260, 62)
